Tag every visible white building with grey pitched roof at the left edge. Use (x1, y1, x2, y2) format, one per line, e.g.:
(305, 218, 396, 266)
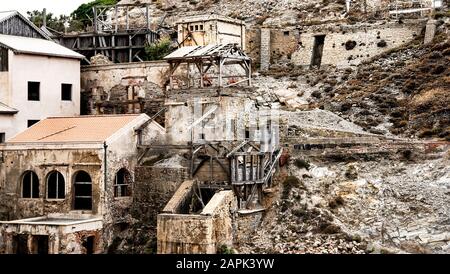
(0, 12, 83, 141)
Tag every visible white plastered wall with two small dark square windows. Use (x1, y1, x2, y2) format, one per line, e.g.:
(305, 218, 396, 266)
(0, 54, 80, 140)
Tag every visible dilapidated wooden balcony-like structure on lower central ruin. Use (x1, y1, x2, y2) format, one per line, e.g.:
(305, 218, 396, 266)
(191, 139, 282, 210)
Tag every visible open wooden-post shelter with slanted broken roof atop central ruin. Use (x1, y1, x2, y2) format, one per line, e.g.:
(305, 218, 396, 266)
(164, 44, 252, 90)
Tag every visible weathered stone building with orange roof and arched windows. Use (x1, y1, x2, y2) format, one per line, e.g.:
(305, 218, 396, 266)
(0, 114, 164, 253)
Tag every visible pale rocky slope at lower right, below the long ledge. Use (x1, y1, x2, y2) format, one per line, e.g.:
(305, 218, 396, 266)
(240, 156, 450, 253)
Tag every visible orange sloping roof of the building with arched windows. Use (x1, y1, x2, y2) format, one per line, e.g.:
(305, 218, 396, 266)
(8, 114, 139, 143)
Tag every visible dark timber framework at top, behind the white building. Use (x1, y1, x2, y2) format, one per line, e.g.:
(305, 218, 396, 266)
(52, 4, 159, 63)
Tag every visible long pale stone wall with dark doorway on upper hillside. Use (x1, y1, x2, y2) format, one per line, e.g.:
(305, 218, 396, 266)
(246, 22, 422, 70)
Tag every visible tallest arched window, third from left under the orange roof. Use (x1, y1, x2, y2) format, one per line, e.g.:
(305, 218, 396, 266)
(73, 171, 92, 210)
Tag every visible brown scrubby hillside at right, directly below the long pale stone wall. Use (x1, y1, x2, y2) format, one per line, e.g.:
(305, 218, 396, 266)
(254, 17, 450, 140)
